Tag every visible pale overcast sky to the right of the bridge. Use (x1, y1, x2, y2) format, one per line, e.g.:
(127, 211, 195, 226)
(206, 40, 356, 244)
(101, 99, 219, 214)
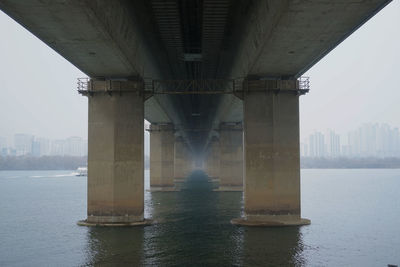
(300, 0, 400, 138)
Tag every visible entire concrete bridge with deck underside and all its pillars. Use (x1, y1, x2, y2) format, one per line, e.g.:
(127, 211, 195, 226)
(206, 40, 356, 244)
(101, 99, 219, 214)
(0, 0, 390, 226)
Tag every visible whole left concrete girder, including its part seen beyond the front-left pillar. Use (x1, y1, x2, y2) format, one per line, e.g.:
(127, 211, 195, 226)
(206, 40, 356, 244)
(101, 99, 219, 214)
(0, 0, 188, 125)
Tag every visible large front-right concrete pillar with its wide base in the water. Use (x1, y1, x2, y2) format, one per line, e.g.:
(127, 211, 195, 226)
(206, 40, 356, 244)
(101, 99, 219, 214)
(232, 80, 310, 226)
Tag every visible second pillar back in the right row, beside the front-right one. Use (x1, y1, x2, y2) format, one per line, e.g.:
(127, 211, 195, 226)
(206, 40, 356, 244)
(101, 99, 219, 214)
(217, 123, 243, 191)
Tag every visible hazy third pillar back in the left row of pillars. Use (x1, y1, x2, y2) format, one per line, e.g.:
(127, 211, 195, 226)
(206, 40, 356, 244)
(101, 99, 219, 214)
(174, 136, 193, 183)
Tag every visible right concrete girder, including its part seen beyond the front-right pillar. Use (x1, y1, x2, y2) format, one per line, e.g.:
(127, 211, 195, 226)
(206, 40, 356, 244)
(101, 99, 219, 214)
(213, 0, 391, 136)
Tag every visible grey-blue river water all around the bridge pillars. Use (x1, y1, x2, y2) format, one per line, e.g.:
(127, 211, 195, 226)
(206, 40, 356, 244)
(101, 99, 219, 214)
(0, 169, 400, 266)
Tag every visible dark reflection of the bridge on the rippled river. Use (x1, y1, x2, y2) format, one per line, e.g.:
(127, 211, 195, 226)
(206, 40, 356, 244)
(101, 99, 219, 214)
(86, 172, 304, 266)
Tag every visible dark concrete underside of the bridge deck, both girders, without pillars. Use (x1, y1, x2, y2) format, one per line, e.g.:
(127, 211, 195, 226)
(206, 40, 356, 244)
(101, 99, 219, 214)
(0, 0, 390, 151)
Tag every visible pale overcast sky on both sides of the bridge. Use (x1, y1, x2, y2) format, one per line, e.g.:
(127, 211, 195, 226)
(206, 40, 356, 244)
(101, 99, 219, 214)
(0, 0, 400, 147)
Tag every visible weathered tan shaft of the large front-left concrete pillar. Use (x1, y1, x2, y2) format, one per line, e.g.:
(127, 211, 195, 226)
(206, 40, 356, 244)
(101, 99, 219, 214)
(87, 81, 144, 224)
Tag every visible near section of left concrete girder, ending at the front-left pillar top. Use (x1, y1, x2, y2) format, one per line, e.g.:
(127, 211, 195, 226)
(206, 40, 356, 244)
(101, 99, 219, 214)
(0, 0, 162, 78)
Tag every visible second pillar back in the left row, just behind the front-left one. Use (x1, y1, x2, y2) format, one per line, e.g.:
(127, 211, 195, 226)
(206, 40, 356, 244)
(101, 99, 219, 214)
(150, 124, 175, 191)
